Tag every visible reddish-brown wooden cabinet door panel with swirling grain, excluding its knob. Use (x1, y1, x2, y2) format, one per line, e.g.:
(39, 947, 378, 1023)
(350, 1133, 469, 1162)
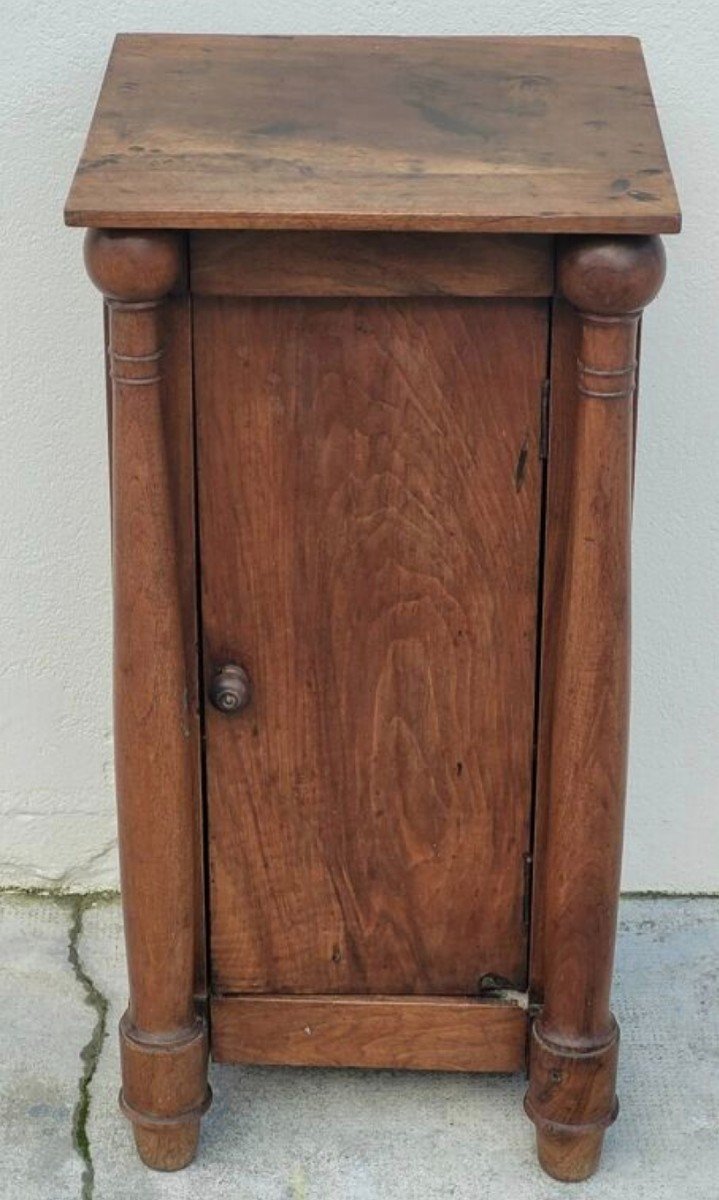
(194, 298, 547, 995)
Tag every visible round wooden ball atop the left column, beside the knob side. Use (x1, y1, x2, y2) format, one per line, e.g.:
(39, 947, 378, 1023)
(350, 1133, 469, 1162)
(84, 229, 182, 302)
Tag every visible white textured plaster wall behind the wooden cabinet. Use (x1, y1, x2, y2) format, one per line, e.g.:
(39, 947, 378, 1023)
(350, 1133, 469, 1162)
(0, 0, 719, 892)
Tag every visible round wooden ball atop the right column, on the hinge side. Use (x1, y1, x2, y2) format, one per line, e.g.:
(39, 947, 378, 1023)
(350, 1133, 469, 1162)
(557, 236, 666, 316)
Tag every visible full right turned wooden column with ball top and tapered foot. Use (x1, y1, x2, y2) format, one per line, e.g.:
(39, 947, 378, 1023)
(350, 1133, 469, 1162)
(526, 236, 664, 1180)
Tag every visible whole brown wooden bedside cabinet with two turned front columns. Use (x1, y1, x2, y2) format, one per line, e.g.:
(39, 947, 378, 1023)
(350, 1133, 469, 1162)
(66, 35, 679, 1180)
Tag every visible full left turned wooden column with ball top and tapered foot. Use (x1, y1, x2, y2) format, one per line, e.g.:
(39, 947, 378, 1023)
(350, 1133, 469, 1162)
(85, 230, 209, 1170)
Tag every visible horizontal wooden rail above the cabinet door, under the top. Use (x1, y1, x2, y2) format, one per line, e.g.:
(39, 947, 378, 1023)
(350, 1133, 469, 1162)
(190, 230, 555, 298)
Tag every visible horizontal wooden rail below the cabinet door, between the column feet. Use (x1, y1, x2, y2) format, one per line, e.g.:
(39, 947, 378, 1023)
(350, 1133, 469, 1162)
(211, 996, 527, 1072)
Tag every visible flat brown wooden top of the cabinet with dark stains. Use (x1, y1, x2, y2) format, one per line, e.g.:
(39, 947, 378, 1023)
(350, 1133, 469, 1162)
(65, 34, 681, 234)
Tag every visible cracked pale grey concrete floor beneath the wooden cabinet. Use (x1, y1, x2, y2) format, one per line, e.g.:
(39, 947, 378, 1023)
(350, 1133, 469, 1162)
(0, 894, 719, 1200)
